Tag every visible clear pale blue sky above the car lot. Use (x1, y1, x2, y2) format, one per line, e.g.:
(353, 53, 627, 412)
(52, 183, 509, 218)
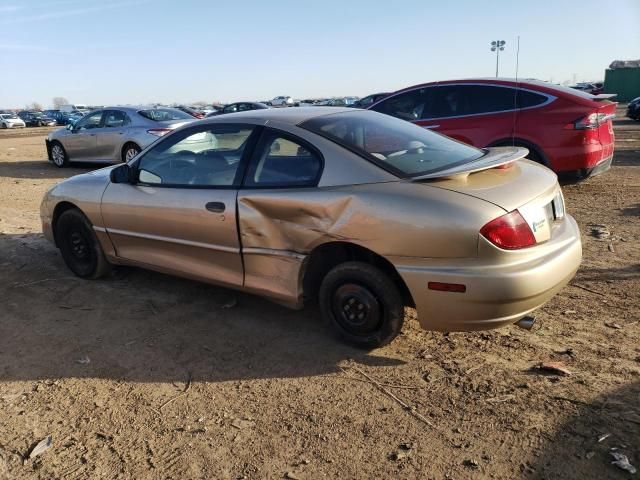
(0, 0, 640, 107)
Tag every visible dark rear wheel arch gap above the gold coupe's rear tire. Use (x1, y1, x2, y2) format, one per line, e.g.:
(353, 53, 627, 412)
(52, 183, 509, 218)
(301, 242, 415, 307)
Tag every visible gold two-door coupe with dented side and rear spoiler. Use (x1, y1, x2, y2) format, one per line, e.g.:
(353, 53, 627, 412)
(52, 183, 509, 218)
(41, 107, 582, 348)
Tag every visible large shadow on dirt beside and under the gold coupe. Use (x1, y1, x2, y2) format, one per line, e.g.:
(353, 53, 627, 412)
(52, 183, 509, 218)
(0, 234, 403, 382)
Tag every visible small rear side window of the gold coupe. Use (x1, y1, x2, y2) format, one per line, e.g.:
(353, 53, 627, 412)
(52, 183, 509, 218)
(245, 131, 322, 187)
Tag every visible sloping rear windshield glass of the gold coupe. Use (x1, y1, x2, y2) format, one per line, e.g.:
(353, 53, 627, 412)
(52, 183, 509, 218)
(300, 111, 484, 178)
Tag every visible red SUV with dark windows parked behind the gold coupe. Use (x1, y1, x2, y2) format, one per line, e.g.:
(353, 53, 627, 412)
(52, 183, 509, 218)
(368, 79, 616, 177)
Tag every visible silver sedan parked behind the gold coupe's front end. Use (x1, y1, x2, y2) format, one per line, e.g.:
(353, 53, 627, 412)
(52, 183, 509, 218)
(45, 107, 195, 167)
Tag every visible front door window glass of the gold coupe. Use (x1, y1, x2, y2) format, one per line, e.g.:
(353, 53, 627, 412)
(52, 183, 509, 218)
(138, 125, 253, 187)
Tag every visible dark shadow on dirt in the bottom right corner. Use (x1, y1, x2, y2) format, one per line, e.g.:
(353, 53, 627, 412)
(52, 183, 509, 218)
(530, 381, 640, 479)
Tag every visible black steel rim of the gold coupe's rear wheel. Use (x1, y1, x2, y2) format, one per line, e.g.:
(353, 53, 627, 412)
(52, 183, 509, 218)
(332, 283, 382, 336)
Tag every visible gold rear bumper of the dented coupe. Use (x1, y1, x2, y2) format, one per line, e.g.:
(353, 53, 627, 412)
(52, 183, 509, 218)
(391, 216, 582, 332)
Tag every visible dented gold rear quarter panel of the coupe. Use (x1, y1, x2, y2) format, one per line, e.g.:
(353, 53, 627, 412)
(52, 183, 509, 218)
(238, 181, 503, 306)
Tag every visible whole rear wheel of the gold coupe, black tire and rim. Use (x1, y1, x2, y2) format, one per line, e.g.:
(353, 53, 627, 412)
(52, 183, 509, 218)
(319, 262, 404, 349)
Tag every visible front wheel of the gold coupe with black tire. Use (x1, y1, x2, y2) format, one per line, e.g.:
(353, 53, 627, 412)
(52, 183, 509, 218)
(55, 209, 111, 279)
